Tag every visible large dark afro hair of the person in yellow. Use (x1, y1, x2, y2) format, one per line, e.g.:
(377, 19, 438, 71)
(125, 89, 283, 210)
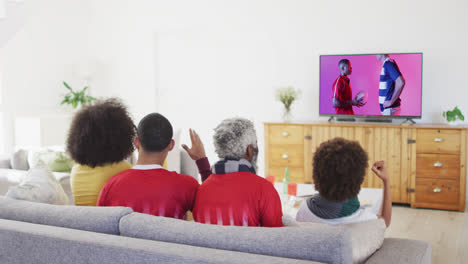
(67, 98, 136, 168)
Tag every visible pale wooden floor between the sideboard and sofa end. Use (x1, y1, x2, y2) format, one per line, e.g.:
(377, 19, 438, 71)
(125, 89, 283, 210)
(385, 205, 468, 264)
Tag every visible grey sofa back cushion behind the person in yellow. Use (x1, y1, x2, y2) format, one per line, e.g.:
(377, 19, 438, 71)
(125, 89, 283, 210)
(0, 197, 133, 235)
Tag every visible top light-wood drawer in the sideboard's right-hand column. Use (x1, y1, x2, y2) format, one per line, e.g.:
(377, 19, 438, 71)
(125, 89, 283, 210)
(416, 129, 460, 154)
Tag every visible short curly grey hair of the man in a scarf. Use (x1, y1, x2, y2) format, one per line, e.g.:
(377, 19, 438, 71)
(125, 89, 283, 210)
(213, 118, 257, 159)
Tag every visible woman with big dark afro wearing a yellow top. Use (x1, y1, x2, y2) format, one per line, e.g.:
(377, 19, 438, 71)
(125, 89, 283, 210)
(67, 98, 136, 206)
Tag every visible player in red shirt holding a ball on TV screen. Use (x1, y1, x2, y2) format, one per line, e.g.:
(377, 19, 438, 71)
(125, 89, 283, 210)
(332, 59, 364, 115)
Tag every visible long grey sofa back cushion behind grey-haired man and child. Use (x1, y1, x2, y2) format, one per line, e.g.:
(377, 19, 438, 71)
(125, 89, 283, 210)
(120, 213, 352, 263)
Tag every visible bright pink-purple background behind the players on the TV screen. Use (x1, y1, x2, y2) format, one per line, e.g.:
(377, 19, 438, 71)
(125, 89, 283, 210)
(320, 54, 422, 116)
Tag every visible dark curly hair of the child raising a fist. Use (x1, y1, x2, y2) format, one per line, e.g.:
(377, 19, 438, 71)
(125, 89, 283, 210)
(313, 138, 368, 202)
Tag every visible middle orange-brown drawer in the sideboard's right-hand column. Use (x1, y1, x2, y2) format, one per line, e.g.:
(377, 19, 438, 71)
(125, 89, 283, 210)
(416, 154, 460, 180)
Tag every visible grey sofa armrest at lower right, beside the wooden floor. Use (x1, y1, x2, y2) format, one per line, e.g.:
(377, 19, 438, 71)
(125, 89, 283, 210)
(366, 238, 431, 264)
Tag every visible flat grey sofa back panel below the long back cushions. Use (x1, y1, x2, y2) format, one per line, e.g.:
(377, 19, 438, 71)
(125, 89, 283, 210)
(0, 219, 316, 264)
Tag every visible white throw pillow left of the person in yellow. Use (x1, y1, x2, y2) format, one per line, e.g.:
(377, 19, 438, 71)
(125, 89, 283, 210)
(6, 165, 70, 205)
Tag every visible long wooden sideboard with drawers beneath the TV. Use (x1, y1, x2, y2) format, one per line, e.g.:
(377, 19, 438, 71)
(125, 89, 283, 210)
(265, 122, 467, 211)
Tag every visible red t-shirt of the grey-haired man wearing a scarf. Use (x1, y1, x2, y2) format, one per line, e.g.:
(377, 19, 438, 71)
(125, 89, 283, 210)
(193, 172, 283, 227)
